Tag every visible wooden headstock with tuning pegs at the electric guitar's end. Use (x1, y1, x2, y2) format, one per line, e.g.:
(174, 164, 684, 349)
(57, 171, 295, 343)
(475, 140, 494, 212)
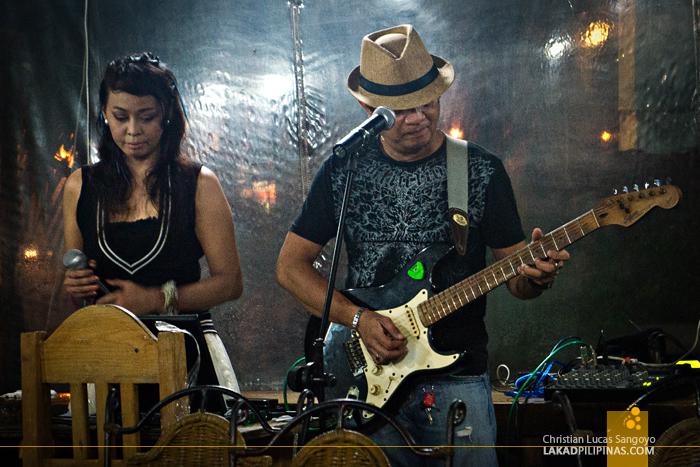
(595, 185, 682, 227)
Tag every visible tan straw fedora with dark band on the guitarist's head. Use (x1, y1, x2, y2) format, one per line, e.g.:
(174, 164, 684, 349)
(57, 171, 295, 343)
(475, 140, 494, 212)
(348, 24, 454, 110)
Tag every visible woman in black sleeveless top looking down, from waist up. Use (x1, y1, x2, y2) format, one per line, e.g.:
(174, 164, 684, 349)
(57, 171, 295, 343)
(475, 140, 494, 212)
(63, 53, 243, 315)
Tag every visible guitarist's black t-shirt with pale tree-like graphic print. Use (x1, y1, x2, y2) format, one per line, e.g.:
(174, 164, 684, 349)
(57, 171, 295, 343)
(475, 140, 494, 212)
(290, 137, 525, 374)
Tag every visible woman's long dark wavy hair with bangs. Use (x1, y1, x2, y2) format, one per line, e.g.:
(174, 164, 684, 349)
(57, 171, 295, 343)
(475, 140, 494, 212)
(90, 52, 191, 219)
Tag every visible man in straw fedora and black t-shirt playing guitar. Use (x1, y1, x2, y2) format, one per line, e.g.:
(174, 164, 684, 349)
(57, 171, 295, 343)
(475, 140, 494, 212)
(277, 25, 569, 466)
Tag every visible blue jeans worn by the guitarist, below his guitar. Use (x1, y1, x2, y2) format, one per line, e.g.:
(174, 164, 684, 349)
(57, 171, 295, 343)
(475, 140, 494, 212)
(370, 373, 498, 467)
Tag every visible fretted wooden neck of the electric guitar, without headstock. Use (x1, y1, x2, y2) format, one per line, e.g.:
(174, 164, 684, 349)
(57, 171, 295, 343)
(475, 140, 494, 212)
(418, 209, 601, 327)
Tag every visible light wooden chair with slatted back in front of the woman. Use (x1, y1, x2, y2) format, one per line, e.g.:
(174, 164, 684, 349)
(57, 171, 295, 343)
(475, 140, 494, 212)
(21, 305, 189, 467)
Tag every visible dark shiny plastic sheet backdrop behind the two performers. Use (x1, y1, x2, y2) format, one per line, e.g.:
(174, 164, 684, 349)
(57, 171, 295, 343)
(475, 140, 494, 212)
(0, 0, 700, 393)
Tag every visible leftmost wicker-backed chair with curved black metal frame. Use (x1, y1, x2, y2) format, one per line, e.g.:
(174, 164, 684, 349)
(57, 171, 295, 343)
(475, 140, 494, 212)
(104, 386, 279, 467)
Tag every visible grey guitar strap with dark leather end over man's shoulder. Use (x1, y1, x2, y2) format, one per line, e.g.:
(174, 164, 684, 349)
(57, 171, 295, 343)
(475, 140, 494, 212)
(445, 135, 469, 255)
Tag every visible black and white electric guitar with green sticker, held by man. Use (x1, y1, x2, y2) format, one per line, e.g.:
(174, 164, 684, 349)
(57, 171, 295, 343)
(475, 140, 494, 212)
(307, 184, 681, 419)
